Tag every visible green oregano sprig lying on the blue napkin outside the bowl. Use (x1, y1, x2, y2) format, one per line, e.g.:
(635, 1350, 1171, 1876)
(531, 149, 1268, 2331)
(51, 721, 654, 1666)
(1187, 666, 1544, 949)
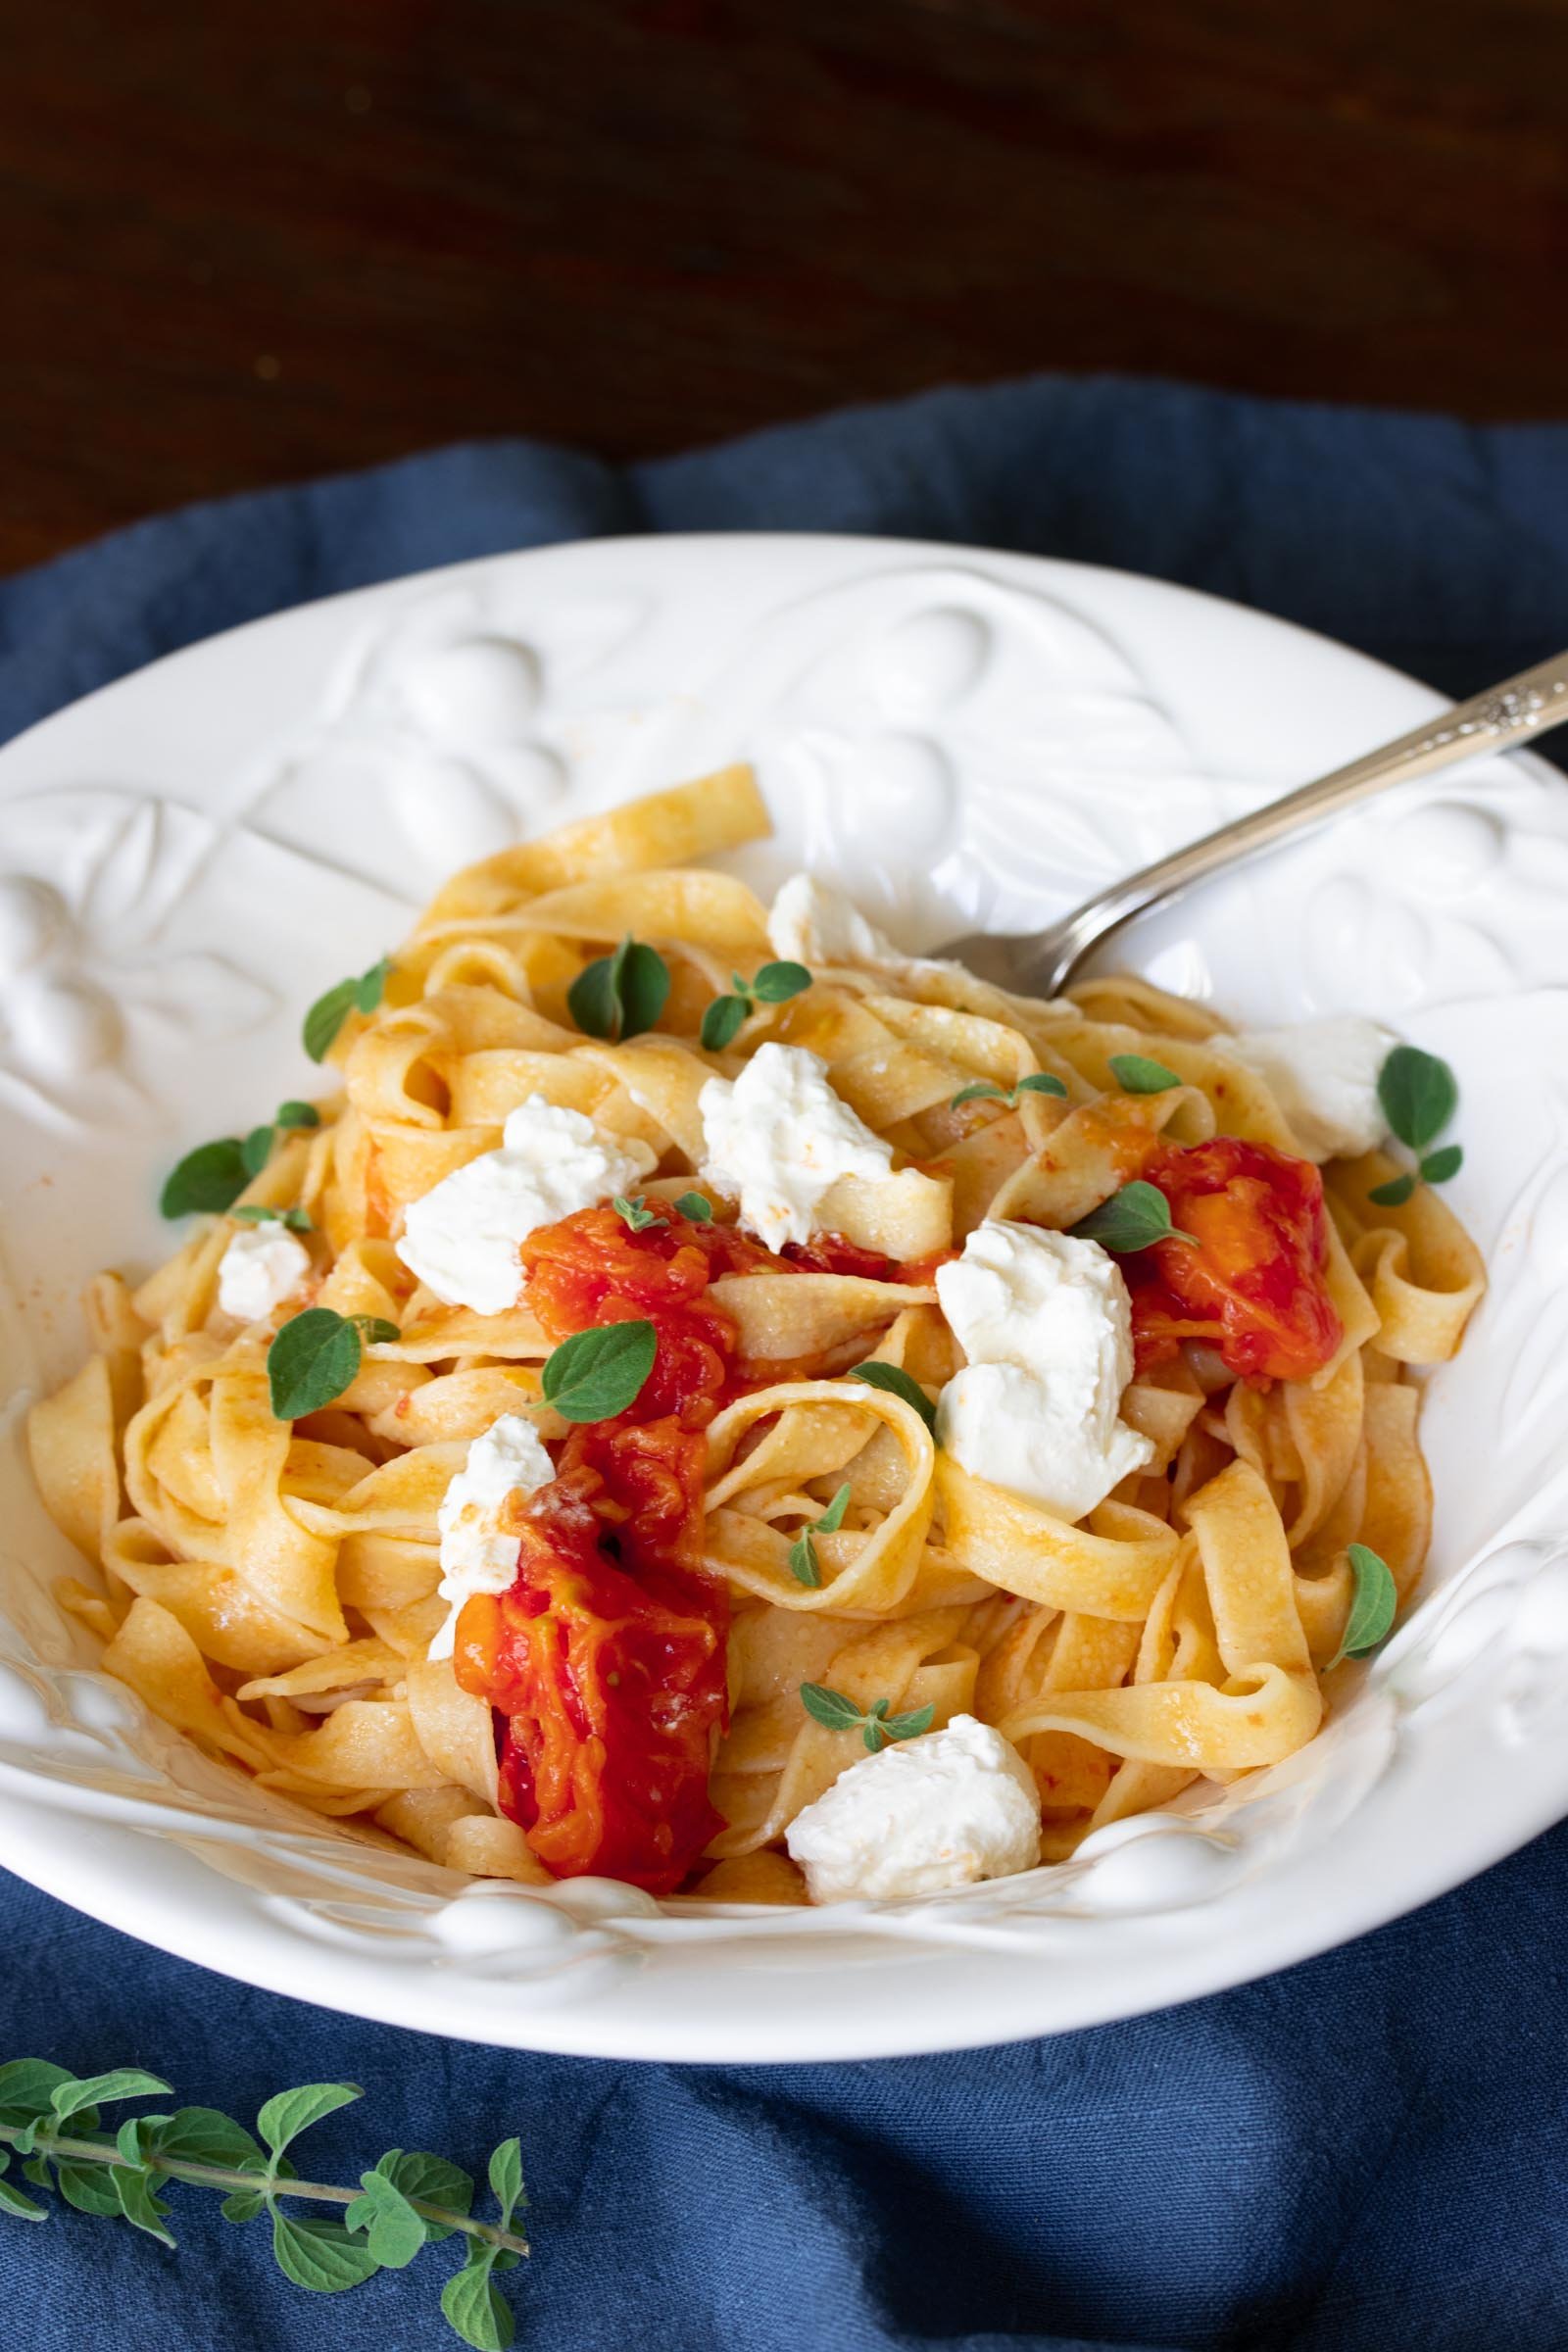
(0, 2058, 529, 2352)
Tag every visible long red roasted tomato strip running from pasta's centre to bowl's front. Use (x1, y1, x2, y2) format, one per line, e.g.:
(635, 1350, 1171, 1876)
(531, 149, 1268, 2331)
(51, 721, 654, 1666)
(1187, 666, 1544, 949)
(454, 1209, 750, 1893)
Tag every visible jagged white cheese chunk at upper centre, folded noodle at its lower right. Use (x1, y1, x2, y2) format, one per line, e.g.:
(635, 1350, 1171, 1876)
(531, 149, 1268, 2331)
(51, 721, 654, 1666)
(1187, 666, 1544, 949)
(698, 1045, 894, 1249)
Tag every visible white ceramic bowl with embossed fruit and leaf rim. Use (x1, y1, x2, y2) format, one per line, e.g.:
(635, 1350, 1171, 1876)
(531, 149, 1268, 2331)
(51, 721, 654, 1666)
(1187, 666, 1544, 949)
(0, 536, 1568, 2060)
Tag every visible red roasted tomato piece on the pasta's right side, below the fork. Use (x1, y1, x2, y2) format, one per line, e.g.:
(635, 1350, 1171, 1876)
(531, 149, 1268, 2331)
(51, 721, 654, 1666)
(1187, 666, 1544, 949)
(1121, 1136, 1343, 1381)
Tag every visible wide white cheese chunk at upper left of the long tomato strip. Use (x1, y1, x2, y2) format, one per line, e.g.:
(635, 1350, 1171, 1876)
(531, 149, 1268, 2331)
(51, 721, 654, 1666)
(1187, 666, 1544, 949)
(397, 1094, 656, 1315)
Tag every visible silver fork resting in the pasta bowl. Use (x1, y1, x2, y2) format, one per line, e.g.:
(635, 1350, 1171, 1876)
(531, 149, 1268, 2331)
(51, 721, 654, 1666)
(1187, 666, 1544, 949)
(938, 652, 1568, 998)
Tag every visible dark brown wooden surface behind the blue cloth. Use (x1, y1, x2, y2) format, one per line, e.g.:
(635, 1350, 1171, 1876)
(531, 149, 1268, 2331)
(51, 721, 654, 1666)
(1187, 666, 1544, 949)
(0, 0, 1568, 569)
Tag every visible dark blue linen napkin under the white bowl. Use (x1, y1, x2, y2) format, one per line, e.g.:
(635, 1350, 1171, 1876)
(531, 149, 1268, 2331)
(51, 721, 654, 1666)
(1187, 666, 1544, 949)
(0, 378, 1568, 2352)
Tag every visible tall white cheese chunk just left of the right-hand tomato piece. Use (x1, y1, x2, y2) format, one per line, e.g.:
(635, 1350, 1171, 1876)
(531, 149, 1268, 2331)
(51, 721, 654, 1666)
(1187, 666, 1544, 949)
(936, 1218, 1154, 1519)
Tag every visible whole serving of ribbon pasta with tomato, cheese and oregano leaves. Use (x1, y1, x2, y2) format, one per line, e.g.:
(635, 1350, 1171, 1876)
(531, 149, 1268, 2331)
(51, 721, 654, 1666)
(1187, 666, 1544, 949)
(30, 766, 1484, 1903)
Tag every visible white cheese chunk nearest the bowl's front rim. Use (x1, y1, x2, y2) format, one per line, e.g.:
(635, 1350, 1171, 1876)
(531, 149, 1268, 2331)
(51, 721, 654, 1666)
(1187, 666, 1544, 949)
(785, 1715, 1039, 1903)
